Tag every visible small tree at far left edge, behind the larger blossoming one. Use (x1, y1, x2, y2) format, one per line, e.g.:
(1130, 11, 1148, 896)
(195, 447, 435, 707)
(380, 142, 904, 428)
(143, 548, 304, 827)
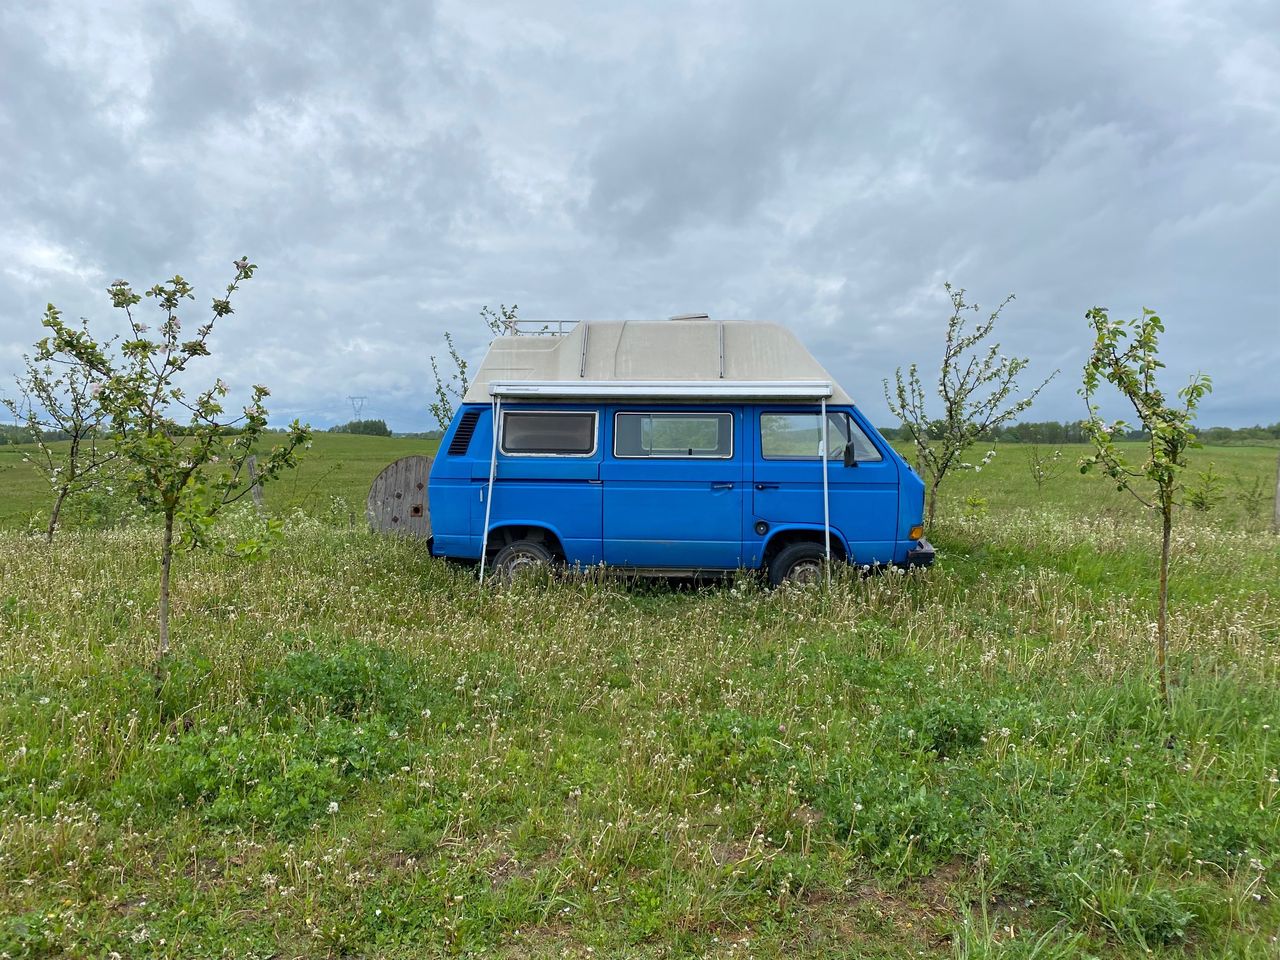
(3, 316, 118, 543)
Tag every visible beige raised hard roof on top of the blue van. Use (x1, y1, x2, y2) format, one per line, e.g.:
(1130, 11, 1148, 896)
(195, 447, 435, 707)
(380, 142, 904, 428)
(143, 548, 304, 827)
(463, 317, 852, 403)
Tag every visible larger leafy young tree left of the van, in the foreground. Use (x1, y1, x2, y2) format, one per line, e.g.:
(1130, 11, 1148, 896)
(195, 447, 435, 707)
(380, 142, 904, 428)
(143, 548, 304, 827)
(37, 257, 311, 657)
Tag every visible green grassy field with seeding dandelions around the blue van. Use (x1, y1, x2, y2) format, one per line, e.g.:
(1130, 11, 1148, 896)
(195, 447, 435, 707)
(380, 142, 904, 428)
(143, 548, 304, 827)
(0, 435, 1280, 960)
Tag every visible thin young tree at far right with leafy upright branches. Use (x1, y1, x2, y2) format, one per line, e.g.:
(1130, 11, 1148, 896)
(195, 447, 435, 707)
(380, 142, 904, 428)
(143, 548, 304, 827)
(1080, 307, 1212, 708)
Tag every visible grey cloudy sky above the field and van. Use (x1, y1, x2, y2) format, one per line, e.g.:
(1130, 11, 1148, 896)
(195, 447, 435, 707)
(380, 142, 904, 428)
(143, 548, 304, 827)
(0, 0, 1280, 430)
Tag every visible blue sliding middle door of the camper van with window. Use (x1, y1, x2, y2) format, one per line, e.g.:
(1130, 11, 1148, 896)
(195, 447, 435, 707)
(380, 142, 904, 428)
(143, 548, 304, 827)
(600, 407, 746, 570)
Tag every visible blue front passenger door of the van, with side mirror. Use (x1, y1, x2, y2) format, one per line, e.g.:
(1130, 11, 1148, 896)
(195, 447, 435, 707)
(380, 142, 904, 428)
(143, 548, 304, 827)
(748, 407, 897, 564)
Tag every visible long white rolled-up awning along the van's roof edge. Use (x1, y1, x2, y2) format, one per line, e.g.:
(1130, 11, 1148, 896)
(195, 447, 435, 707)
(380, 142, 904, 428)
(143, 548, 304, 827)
(489, 380, 832, 402)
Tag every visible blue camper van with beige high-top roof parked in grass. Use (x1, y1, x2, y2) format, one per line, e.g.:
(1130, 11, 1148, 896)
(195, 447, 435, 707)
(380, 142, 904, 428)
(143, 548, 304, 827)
(428, 315, 933, 585)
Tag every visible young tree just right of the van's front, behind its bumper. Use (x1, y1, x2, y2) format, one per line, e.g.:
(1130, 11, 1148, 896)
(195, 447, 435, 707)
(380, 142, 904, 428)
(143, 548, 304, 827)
(884, 283, 1057, 527)
